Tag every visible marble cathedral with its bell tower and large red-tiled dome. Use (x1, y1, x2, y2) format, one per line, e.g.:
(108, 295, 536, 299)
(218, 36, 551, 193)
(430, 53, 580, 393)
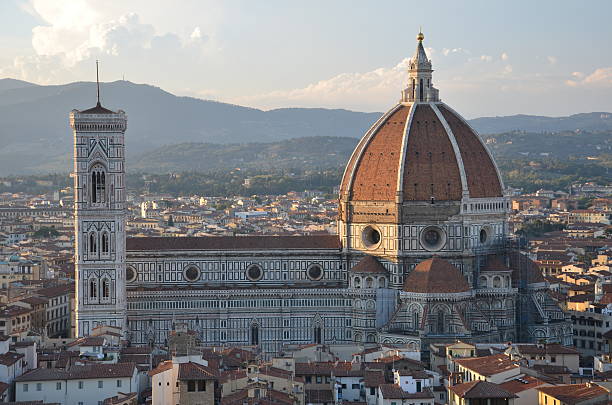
(70, 33, 572, 354)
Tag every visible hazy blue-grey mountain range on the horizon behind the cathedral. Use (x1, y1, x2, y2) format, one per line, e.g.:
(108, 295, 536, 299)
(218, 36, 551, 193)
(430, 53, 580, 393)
(0, 79, 612, 176)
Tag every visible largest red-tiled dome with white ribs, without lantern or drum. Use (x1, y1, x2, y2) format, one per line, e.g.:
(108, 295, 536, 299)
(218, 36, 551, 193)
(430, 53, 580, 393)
(340, 102, 502, 202)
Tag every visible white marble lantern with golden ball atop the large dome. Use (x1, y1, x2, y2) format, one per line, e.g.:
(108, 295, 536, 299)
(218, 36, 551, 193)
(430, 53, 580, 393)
(401, 31, 439, 103)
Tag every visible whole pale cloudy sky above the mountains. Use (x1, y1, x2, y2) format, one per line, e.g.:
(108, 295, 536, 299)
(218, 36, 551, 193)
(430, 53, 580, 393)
(0, 0, 612, 118)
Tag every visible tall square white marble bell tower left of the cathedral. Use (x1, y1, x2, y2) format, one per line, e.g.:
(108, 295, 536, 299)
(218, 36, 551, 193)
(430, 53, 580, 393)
(70, 68, 127, 337)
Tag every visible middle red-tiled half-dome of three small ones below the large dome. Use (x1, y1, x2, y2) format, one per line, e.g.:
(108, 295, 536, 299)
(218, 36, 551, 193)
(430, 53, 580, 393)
(404, 257, 471, 294)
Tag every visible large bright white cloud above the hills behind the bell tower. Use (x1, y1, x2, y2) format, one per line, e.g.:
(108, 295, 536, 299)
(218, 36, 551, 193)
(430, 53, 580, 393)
(0, 0, 219, 87)
